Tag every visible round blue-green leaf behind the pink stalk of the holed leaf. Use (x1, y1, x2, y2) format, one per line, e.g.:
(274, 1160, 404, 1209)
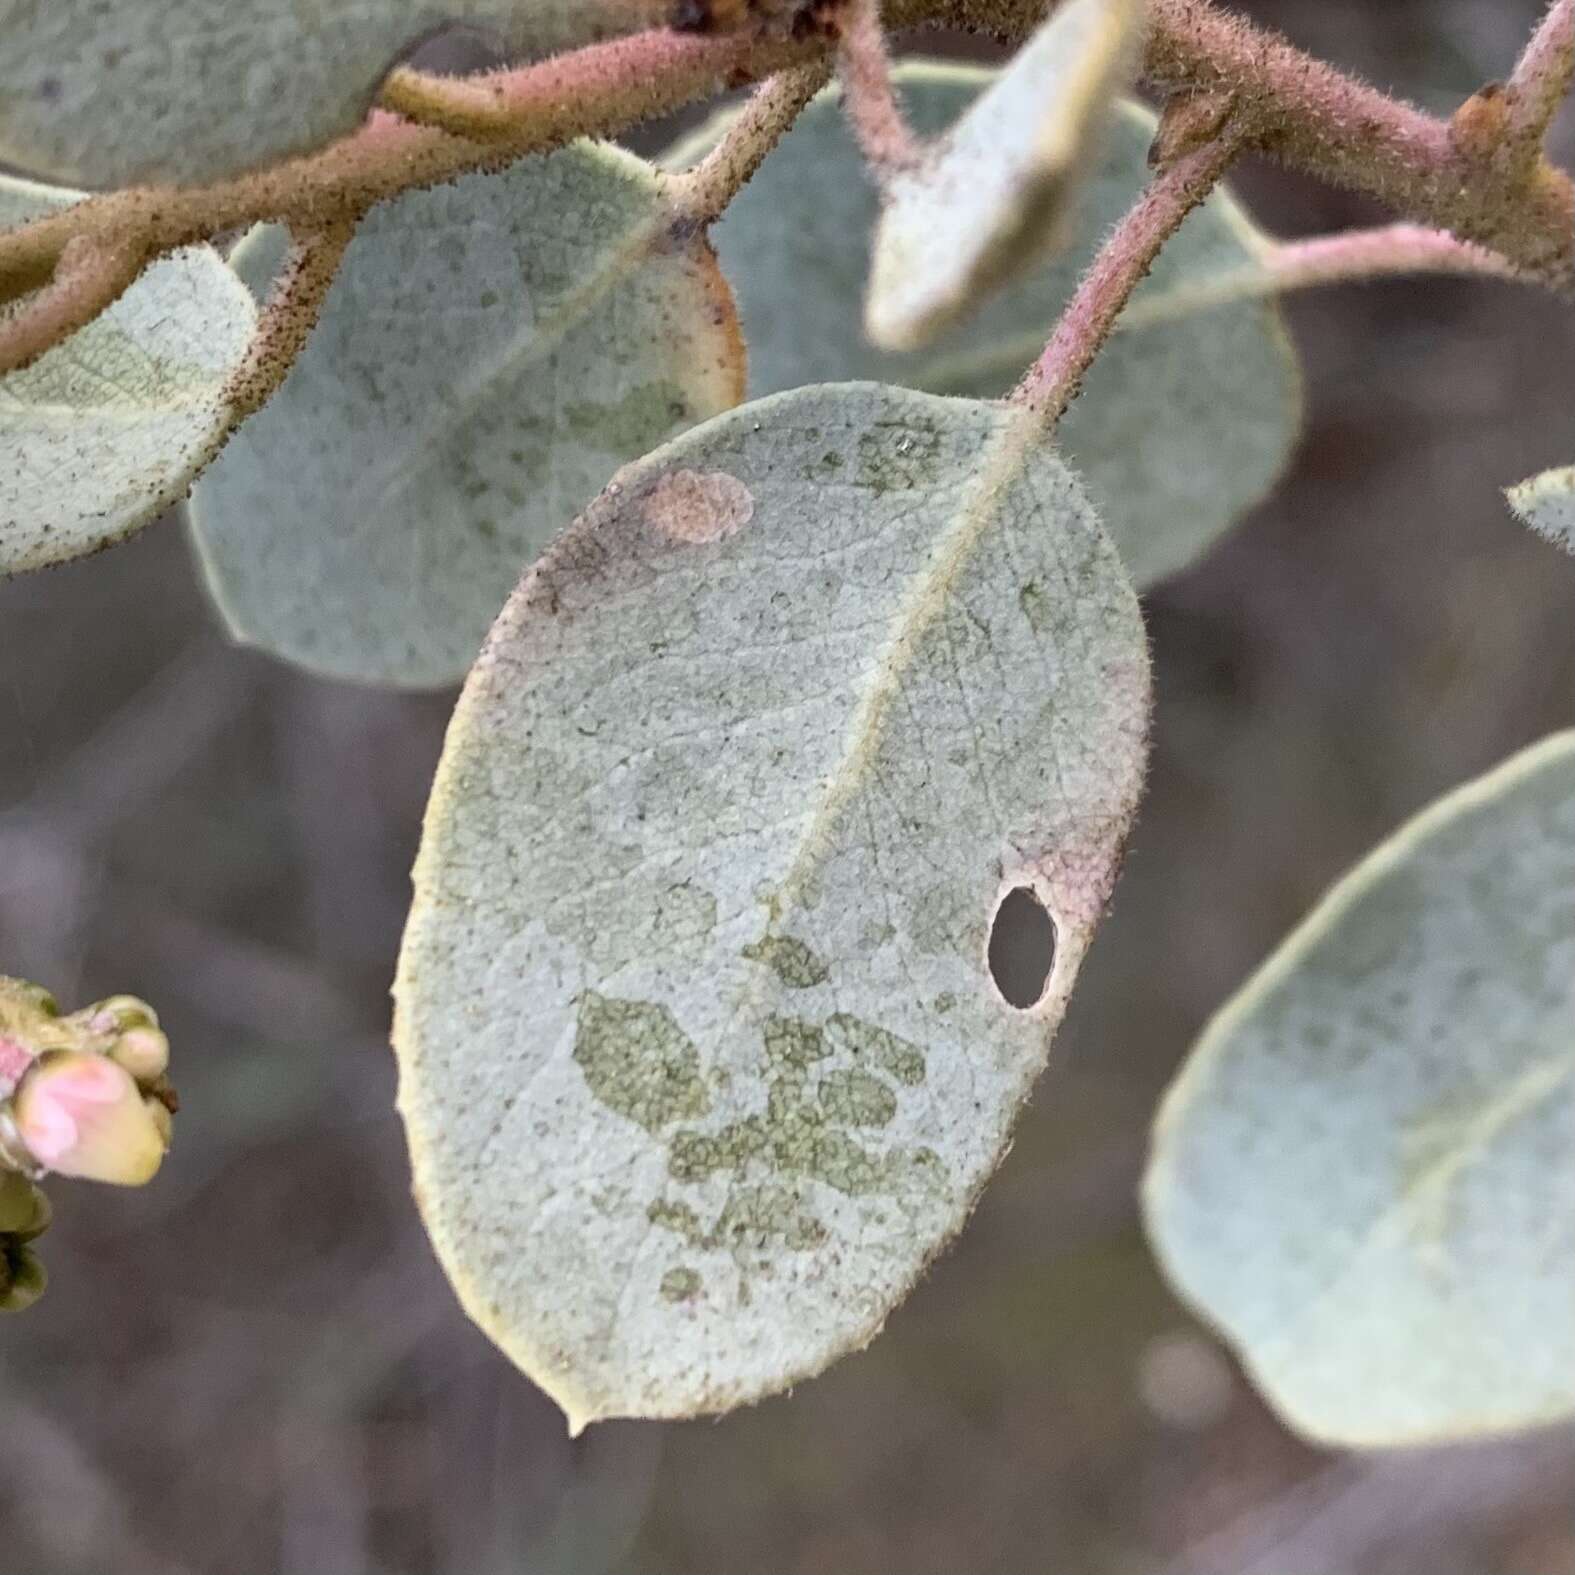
(668, 63, 1301, 587)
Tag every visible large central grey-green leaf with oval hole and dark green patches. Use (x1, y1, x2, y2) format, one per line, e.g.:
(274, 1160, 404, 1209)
(395, 384, 1148, 1430)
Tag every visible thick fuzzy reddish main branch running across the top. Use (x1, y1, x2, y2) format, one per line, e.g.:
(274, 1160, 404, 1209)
(0, 0, 1575, 348)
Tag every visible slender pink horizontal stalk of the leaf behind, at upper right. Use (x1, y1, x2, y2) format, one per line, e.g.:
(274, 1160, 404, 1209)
(1118, 224, 1526, 329)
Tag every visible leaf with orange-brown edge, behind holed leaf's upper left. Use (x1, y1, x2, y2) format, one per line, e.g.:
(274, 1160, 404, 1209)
(192, 143, 743, 685)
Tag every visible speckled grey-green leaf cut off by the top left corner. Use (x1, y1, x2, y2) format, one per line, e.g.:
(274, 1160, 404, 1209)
(0, 0, 658, 186)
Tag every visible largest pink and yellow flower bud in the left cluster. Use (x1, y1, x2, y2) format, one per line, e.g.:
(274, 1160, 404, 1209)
(11, 1051, 165, 1186)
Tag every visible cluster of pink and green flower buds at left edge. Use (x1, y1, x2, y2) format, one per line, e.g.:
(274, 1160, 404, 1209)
(0, 977, 178, 1312)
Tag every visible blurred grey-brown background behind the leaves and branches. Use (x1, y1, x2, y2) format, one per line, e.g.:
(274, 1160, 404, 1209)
(9, 0, 1575, 1575)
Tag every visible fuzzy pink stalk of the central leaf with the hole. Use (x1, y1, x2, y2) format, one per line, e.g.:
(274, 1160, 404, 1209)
(1011, 128, 1243, 432)
